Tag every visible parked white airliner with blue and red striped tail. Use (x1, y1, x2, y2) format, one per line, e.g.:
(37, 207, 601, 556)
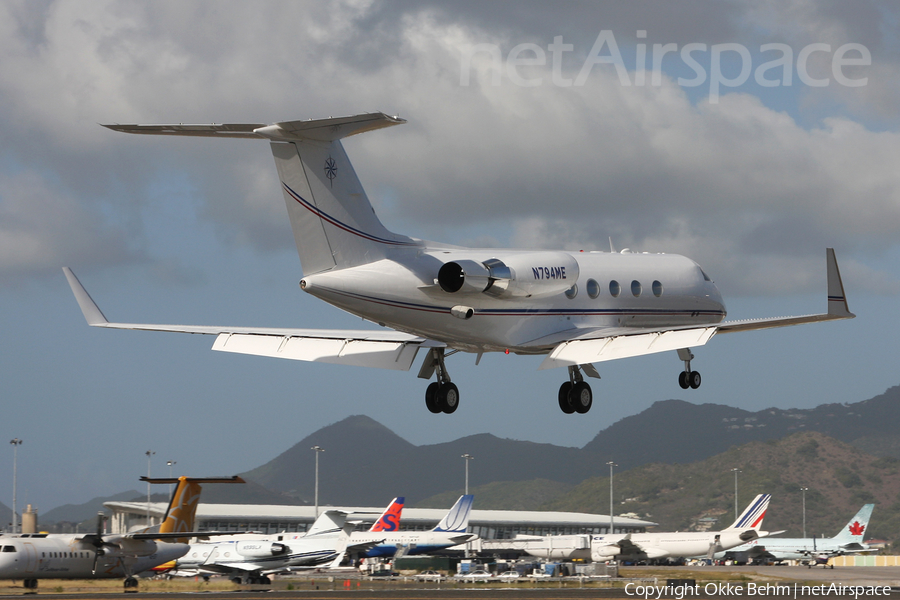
(516, 494, 771, 562)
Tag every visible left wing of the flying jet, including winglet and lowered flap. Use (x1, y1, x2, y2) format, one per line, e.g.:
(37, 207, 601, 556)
(63, 267, 444, 370)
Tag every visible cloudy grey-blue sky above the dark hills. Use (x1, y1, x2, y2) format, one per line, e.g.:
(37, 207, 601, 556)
(0, 0, 900, 524)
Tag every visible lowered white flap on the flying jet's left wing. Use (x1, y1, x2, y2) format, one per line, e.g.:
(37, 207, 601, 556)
(212, 333, 419, 371)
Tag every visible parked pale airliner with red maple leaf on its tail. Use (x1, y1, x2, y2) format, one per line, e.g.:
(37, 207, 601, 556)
(717, 504, 875, 568)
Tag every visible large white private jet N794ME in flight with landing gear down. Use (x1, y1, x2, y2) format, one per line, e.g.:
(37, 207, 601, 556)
(64, 113, 854, 414)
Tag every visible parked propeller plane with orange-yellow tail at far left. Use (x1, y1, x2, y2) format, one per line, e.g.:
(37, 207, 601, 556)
(0, 477, 244, 590)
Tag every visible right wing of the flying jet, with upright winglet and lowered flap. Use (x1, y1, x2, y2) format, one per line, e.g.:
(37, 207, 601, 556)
(528, 248, 856, 369)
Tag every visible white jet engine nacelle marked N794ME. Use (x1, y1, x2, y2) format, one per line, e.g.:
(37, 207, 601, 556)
(437, 252, 578, 298)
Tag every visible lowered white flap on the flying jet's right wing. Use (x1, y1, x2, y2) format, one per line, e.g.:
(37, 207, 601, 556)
(540, 326, 716, 369)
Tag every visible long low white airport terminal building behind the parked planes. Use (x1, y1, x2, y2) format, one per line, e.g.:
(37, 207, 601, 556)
(104, 502, 656, 540)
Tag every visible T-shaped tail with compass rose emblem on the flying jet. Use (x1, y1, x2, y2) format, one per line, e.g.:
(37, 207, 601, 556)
(106, 113, 417, 275)
